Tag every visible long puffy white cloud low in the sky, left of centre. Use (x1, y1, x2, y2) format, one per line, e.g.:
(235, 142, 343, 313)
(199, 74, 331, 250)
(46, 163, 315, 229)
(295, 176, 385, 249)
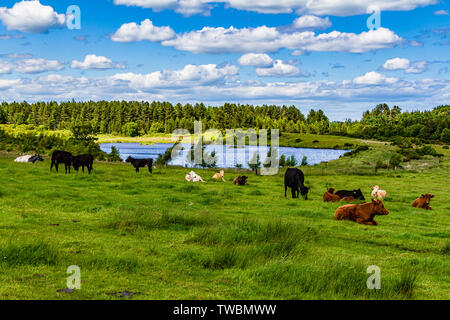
(111, 64, 239, 89)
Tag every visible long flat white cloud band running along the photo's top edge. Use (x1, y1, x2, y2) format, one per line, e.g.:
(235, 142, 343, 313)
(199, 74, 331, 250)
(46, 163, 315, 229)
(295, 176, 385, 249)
(114, 0, 438, 16)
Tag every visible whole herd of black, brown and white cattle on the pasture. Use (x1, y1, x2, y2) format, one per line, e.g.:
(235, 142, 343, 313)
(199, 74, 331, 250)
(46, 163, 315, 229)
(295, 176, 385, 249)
(15, 150, 434, 226)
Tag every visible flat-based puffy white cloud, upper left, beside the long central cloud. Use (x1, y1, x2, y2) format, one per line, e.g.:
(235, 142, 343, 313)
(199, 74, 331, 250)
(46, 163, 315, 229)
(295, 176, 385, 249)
(111, 19, 175, 42)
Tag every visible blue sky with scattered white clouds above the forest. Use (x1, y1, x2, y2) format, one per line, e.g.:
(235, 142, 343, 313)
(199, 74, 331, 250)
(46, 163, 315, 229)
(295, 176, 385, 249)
(0, 0, 450, 120)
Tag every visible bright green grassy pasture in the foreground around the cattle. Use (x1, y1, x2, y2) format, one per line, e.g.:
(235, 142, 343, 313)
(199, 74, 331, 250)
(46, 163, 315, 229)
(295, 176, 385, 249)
(0, 144, 450, 299)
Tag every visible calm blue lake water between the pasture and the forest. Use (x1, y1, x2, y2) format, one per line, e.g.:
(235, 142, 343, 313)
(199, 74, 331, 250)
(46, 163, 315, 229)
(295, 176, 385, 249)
(100, 143, 348, 168)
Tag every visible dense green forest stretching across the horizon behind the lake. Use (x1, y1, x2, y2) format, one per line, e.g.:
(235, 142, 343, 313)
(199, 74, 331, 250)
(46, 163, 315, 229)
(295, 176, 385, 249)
(0, 101, 450, 143)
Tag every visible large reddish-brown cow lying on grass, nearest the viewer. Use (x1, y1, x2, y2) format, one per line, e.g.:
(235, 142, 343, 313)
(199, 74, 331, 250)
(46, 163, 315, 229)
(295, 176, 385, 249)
(334, 199, 389, 226)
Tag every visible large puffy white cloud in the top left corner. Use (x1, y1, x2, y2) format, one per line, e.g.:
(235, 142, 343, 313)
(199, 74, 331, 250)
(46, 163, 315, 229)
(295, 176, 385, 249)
(0, 0, 66, 33)
